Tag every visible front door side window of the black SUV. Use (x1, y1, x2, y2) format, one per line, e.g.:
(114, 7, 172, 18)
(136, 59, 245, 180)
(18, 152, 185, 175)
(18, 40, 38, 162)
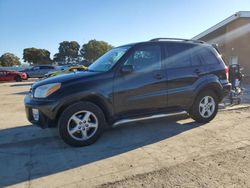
(124, 45, 161, 72)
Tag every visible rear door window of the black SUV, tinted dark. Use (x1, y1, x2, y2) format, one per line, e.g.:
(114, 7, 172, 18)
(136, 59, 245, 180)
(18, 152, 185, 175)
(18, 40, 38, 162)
(165, 43, 192, 68)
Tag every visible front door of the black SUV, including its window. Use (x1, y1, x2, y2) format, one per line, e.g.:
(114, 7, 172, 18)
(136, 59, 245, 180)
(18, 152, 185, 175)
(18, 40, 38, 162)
(114, 44, 166, 116)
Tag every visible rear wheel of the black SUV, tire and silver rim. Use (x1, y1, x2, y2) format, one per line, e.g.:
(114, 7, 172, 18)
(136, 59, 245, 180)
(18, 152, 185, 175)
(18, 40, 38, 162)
(189, 90, 218, 123)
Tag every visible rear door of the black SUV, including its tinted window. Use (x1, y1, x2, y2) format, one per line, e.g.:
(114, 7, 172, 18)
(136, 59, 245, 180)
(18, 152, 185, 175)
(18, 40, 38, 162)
(164, 42, 207, 107)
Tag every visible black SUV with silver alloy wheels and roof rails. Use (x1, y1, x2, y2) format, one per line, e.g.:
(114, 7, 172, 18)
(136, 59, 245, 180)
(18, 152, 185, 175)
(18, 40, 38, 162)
(25, 38, 231, 146)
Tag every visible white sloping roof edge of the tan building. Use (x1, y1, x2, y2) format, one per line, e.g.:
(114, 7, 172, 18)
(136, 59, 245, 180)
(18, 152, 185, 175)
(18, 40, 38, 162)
(192, 11, 250, 40)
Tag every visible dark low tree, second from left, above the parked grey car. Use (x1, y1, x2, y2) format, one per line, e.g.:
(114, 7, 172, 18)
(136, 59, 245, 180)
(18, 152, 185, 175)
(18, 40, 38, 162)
(23, 48, 52, 65)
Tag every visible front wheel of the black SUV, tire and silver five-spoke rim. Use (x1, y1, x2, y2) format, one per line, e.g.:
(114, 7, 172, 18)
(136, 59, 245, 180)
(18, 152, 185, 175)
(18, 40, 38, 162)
(58, 102, 106, 147)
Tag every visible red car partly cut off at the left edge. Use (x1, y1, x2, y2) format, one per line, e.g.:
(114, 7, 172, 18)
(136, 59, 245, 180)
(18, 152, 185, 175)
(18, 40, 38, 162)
(0, 70, 27, 82)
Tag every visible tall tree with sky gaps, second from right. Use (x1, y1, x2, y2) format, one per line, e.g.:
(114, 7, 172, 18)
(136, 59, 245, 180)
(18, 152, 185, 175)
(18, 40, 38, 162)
(53, 41, 80, 62)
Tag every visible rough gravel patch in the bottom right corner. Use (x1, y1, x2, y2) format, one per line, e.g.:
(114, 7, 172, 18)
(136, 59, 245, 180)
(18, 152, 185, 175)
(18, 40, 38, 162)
(100, 143, 250, 188)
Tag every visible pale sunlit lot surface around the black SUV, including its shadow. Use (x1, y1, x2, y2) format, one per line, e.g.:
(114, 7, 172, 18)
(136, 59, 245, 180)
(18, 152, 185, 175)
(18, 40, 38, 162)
(0, 82, 250, 187)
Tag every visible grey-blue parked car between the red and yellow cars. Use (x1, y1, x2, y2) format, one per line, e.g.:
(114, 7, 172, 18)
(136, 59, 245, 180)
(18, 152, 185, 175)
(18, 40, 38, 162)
(22, 65, 57, 78)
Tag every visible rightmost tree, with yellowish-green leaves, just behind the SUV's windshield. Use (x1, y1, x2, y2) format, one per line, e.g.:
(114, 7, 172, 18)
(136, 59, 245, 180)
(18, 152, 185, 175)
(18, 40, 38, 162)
(80, 40, 113, 62)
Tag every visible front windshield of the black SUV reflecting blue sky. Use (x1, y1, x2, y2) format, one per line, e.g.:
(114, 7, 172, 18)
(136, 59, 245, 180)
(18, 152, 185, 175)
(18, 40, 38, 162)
(87, 46, 131, 72)
